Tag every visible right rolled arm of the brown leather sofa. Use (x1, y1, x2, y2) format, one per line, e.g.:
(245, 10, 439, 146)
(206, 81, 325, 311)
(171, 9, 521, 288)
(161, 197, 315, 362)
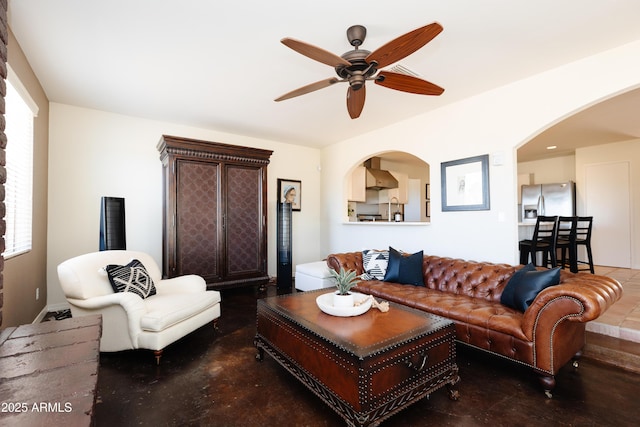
(522, 272, 622, 338)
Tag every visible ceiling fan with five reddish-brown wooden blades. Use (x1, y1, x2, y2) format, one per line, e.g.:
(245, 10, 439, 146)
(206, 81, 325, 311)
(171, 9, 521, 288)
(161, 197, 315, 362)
(276, 22, 444, 119)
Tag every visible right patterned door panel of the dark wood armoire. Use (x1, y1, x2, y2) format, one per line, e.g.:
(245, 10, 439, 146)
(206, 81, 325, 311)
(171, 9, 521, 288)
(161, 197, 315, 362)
(225, 165, 264, 276)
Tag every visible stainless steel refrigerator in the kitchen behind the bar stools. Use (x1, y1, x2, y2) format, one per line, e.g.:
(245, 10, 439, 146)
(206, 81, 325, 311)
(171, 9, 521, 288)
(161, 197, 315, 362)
(522, 181, 576, 223)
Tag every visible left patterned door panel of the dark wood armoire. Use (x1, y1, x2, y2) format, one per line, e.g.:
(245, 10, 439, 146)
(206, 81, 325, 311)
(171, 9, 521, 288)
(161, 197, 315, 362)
(176, 160, 220, 281)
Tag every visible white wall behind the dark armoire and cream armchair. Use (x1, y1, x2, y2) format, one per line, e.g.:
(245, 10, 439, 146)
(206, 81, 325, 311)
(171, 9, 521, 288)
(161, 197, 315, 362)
(47, 103, 322, 306)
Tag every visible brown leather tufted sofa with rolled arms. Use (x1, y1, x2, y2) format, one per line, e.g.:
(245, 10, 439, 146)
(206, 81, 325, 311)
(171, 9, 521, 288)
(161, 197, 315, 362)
(327, 252, 622, 397)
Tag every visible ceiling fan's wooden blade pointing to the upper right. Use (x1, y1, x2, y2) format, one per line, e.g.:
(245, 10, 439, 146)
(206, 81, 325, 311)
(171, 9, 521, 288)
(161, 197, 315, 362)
(366, 22, 442, 68)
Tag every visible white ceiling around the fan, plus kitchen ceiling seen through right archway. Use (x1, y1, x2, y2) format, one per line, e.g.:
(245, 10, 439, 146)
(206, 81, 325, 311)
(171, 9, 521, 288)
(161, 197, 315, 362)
(9, 0, 640, 160)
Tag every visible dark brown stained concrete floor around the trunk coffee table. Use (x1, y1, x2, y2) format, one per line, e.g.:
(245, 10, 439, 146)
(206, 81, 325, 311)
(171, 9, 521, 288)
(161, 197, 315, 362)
(95, 286, 640, 427)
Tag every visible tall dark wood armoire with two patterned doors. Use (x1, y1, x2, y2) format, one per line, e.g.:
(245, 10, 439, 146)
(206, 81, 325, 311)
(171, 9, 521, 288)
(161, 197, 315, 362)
(158, 135, 272, 289)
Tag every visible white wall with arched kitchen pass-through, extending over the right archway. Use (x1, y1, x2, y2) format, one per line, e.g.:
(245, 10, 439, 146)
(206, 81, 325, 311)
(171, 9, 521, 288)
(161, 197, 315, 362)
(322, 41, 640, 263)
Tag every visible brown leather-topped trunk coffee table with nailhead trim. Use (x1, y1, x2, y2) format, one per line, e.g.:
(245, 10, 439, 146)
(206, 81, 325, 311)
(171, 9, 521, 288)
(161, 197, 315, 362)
(255, 289, 460, 426)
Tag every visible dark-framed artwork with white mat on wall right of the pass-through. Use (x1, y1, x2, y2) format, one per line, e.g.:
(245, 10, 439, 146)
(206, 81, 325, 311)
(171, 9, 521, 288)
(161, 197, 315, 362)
(441, 154, 489, 211)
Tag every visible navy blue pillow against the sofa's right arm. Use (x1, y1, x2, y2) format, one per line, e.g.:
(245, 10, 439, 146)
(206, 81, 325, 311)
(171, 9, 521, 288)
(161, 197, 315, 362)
(500, 267, 560, 312)
